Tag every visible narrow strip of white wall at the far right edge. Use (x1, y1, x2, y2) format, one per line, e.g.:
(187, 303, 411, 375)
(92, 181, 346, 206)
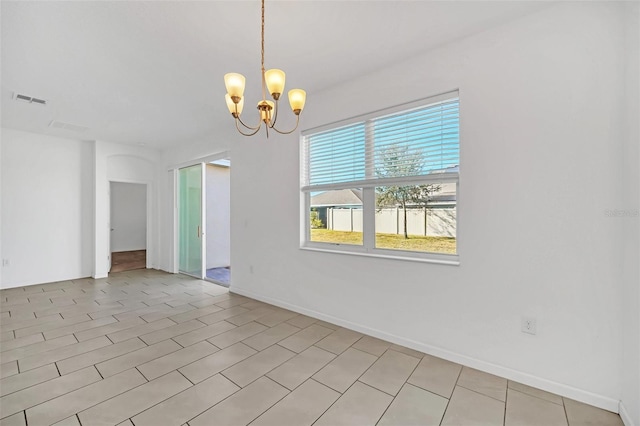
(612, 2, 640, 425)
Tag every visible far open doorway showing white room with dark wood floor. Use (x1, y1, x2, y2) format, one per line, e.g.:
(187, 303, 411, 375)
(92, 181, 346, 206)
(109, 182, 147, 272)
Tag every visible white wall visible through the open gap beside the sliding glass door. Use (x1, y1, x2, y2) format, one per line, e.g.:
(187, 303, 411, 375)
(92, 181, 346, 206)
(206, 164, 231, 269)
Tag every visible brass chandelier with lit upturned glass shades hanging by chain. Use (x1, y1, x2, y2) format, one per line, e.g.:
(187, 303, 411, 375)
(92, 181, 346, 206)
(224, 0, 307, 137)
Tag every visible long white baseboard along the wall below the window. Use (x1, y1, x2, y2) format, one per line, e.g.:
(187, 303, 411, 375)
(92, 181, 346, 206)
(229, 286, 620, 414)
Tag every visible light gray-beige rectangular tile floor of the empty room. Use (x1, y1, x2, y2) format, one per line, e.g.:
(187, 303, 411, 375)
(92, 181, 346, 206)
(0, 270, 622, 426)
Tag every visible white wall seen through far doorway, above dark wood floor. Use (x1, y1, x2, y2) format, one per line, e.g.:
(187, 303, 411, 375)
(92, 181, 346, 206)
(111, 182, 147, 252)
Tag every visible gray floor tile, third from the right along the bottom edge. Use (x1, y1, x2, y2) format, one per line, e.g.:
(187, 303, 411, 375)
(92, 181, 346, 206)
(442, 386, 504, 426)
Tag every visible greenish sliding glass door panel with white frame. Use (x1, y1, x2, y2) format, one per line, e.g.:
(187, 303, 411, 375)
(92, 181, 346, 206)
(178, 164, 204, 279)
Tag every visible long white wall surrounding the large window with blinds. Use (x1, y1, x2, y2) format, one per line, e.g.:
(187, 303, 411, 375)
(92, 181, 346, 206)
(225, 2, 637, 411)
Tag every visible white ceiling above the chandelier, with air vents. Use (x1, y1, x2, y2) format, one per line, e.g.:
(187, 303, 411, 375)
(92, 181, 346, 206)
(1, 0, 548, 149)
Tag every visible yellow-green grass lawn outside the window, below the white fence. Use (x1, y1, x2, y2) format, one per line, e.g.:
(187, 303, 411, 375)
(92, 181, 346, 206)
(311, 229, 456, 254)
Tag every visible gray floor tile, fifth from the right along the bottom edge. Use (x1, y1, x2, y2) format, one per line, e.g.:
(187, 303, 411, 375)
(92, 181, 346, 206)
(314, 382, 393, 426)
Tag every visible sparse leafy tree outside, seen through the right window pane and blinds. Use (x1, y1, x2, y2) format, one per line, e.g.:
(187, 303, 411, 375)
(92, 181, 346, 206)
(375, 143, 441, 239)
